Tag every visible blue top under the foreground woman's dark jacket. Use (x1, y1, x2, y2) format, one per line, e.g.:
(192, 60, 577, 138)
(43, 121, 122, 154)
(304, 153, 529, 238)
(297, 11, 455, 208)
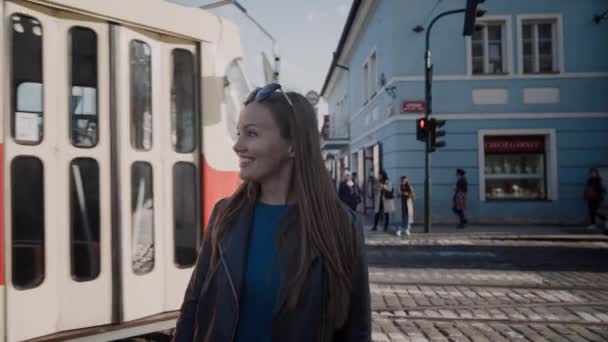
(234, 202, 287, 342)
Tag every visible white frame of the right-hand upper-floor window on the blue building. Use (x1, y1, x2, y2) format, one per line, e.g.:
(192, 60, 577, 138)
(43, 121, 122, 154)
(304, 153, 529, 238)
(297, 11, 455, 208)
(517, 13, 566, 75)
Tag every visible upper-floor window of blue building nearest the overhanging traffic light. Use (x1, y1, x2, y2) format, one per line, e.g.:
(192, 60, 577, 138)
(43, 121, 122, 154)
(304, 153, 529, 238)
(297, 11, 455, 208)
(471, 21, 508, 75)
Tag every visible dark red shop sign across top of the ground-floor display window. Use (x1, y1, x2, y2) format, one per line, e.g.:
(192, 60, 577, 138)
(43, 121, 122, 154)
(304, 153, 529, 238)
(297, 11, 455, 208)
(484, 135, 545, 153)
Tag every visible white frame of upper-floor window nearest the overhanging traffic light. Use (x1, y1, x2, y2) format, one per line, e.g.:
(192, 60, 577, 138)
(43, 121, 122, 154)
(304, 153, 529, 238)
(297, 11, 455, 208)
(465, 15, 514, 77)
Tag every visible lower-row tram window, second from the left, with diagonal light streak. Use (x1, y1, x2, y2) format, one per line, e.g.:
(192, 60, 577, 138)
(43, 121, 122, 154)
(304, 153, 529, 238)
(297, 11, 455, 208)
(70, 158, 100, 281)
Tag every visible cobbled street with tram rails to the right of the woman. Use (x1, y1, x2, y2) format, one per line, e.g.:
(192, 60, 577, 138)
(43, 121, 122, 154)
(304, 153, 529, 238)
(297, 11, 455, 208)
(367, 235, 608, 342)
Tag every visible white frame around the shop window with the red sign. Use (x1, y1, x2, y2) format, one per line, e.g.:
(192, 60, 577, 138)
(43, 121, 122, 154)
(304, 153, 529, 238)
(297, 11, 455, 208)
(477, 128, 559, 202)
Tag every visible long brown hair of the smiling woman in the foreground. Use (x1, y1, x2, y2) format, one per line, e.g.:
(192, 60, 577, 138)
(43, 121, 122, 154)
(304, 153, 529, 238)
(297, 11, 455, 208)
(211, 92, 355, 326)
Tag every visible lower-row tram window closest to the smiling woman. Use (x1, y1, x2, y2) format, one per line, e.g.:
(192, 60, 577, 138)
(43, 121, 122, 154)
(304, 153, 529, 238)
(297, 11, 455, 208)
(173, 162, 202, 267)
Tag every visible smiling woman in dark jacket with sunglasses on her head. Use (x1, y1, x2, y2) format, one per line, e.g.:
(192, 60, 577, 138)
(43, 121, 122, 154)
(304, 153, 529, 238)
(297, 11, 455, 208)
(174, 83, 371, 342)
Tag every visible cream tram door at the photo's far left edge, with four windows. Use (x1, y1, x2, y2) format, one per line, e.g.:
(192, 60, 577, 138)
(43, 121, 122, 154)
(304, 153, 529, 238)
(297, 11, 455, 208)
(3, 2, 112, 341)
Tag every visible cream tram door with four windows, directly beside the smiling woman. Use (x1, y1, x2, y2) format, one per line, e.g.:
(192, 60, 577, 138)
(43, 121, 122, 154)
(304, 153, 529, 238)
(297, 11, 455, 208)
(112, 26, 201, 320)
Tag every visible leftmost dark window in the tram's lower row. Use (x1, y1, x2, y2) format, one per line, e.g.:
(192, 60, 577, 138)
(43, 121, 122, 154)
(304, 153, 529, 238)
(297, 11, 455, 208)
(11, 157, 45, 289)
